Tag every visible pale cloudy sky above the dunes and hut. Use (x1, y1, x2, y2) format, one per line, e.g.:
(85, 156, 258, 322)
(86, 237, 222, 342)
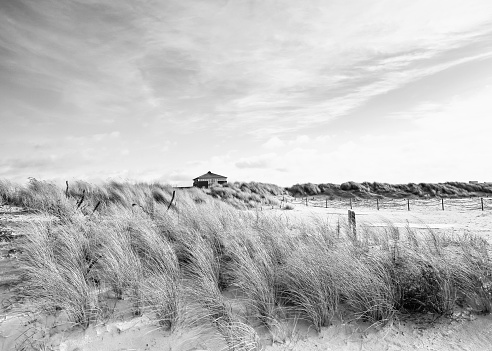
(0, 0, 492, 186)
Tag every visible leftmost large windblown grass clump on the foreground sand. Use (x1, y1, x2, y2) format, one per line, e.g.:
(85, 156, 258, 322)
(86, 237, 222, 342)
(19, 222, 100, 327)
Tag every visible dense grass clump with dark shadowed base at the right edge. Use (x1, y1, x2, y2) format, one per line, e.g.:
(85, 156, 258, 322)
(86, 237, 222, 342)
(358, 226, 491, 315)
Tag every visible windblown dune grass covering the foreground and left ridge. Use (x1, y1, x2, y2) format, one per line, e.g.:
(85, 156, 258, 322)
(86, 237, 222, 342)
(0, 180, 492, 350)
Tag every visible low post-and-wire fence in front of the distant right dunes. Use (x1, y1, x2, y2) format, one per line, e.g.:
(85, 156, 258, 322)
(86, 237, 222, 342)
(279, 196, 492, 211)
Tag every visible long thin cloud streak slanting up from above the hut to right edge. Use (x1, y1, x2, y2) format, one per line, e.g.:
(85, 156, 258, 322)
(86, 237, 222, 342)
(217, 39, 492, 136)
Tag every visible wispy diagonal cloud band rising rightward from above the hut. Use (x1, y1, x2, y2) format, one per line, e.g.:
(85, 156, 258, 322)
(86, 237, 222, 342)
(215, 27, 492, 135)
